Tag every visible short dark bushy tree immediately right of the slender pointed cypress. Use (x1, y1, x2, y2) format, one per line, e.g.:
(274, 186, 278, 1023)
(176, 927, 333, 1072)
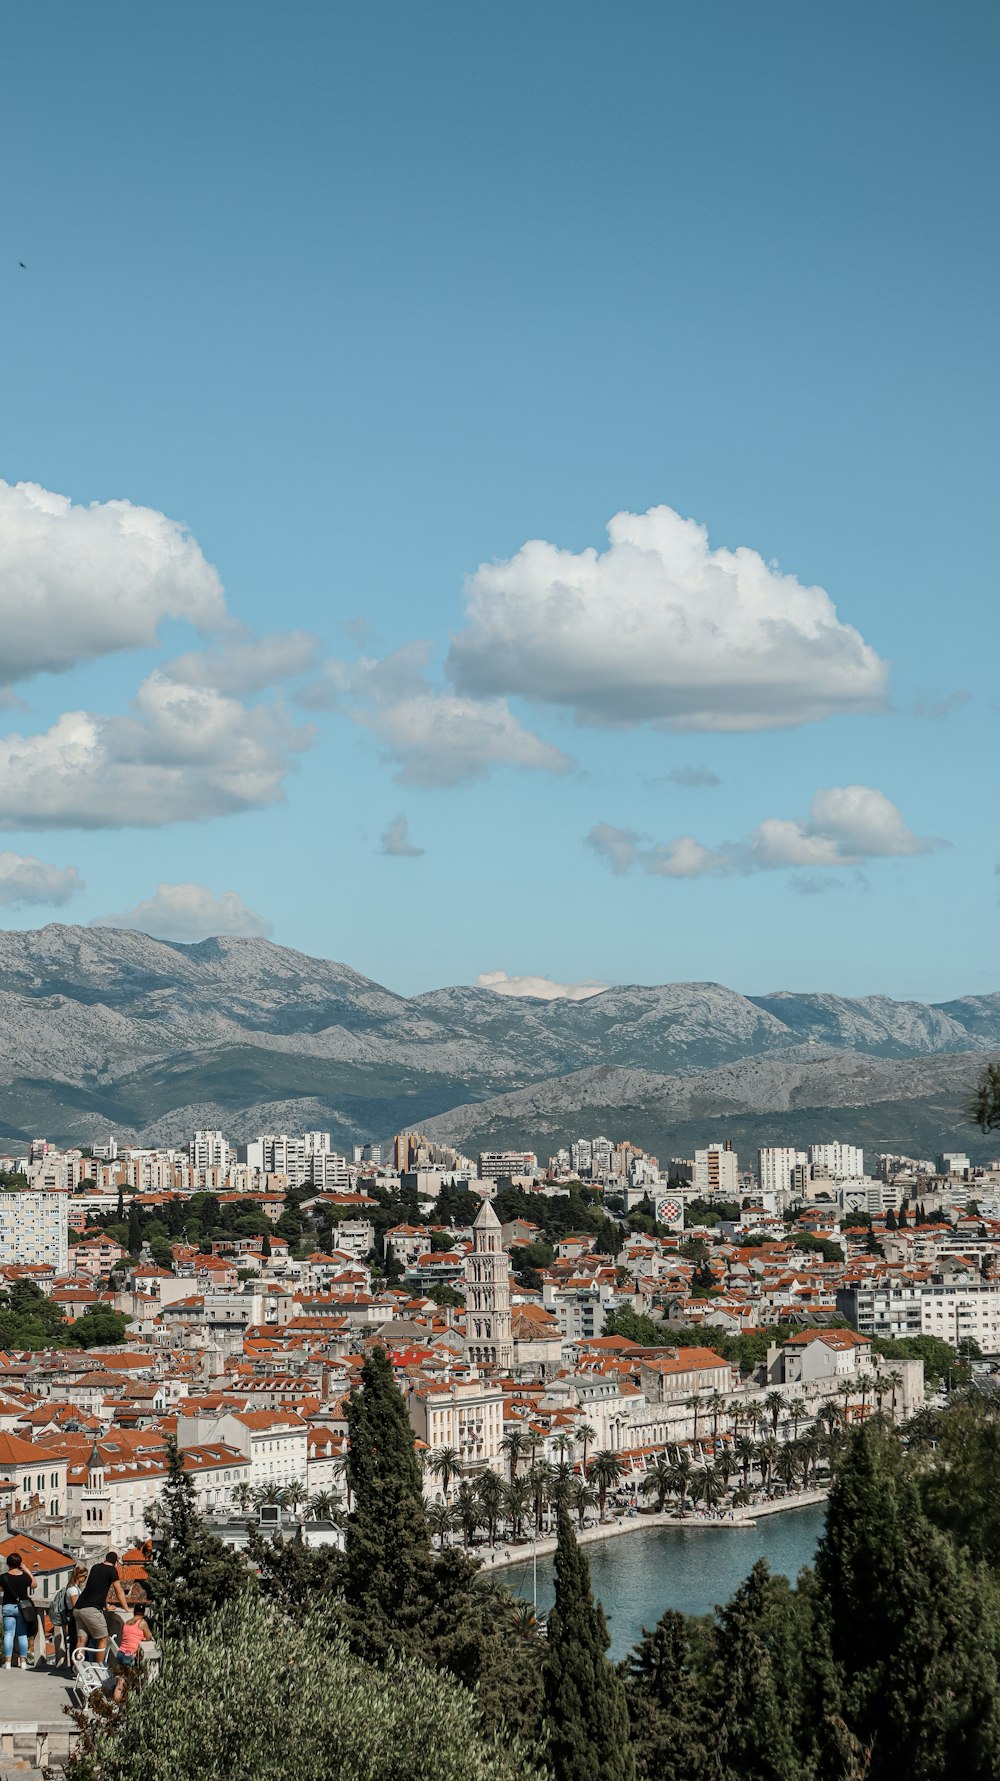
(622, 1608, 718, 1781)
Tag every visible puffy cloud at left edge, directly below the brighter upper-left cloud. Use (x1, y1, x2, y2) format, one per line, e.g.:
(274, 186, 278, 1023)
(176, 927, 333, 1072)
(0, 670, 310, 828)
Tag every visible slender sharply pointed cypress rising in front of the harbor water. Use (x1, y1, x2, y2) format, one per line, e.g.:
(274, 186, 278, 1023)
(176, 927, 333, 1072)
(544, 1501, 635, 1781)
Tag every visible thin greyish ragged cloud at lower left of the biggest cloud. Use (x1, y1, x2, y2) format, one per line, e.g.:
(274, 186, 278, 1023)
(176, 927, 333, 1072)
(301, 643, 572, 785)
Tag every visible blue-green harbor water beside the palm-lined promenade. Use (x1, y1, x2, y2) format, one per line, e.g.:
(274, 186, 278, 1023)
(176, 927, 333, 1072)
(508, 1503, 825, 1658)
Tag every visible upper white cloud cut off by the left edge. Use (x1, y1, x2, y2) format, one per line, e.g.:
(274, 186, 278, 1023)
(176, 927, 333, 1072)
(0, 481, 225, 686)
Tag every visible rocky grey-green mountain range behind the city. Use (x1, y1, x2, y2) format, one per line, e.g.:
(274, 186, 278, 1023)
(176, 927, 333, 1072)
(0, 924, 1000, 1161)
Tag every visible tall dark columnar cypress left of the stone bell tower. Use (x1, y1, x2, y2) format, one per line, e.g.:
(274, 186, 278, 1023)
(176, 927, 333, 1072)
(344, 1348, 433, 1662)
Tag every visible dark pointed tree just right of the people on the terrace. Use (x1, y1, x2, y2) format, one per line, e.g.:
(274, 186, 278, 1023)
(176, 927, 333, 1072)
(148, 1435, 251, 1635)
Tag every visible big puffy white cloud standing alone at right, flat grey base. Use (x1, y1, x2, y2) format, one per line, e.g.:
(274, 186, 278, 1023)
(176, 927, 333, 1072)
(447, 508, 888, 730)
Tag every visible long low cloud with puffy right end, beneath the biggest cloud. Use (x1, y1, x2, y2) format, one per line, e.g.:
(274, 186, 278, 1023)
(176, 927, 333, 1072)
(585, 785, 943, 883)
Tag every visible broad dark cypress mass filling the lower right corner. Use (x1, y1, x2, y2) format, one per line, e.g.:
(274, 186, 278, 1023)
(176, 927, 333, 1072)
(816, 1421, 1000, 1781)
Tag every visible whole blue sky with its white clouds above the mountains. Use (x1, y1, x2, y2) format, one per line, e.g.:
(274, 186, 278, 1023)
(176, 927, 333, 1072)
(0, 0, 1000, 999)
